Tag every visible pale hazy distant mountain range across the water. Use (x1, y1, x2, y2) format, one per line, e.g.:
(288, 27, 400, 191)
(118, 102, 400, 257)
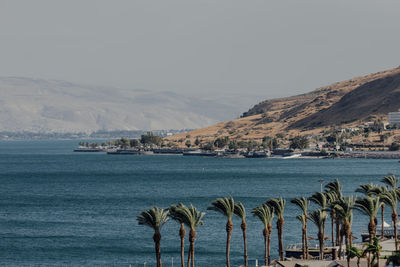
(0, 77, 262, 133)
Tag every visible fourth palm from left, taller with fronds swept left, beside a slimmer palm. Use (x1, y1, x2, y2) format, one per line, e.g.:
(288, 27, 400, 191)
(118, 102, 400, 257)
(207, 197, 235, 267)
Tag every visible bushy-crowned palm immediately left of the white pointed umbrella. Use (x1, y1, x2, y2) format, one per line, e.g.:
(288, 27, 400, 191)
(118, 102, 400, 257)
(355, 196, 382, 242)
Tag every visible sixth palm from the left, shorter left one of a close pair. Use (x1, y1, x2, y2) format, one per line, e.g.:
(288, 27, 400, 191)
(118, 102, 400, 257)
(251, 204, 274, 266)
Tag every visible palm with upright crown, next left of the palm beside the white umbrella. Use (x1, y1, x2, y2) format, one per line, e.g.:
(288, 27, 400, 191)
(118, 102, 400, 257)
(335, 196, 356, 255)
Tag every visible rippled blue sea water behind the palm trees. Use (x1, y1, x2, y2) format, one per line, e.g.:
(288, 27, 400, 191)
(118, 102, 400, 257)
(0, 141, 400, 267)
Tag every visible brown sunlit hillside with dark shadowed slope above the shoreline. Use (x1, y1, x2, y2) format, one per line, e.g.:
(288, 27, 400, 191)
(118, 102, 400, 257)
(167, 67, 400, 147)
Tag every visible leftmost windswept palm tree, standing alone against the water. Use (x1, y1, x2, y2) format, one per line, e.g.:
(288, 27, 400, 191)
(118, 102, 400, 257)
(136, 207, 169, 267)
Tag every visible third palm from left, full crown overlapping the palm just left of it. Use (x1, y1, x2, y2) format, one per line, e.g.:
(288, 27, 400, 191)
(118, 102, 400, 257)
(173, 204, 205, 267)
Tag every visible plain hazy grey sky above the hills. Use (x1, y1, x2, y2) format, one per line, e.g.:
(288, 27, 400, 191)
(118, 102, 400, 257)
(0, 0, 400, 97)
